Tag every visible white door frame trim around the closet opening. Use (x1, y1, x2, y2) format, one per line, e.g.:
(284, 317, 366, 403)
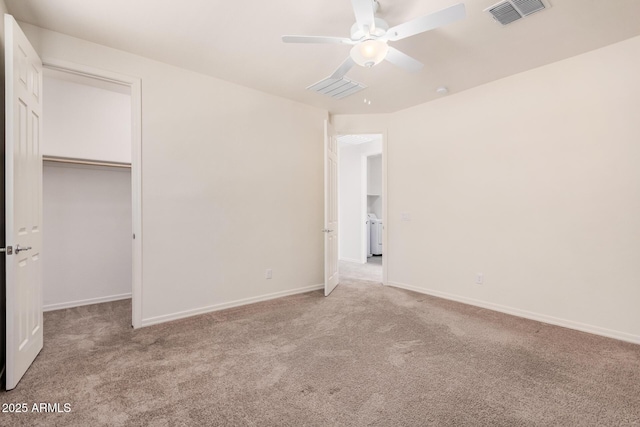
(42, 57, 143, 329)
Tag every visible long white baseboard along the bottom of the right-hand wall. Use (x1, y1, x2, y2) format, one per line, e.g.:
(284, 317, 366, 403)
(387, 282, 640, 344)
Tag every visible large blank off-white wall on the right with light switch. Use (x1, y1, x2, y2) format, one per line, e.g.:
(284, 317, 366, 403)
(335, 37, 640, 342)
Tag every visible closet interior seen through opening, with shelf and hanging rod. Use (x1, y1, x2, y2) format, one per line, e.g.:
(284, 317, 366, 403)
(42, 65, 139, 325)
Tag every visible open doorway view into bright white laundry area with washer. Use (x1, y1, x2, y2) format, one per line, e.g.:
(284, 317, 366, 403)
(338, 134, 385, 283)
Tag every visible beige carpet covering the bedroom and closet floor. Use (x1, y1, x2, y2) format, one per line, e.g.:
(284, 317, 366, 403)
(0, 280, 640, 426)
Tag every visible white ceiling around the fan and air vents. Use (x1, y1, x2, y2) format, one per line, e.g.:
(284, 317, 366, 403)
(5, 0, 640, 113)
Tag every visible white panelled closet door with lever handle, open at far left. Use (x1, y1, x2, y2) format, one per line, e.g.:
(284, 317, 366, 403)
(4, 15, 42, 390)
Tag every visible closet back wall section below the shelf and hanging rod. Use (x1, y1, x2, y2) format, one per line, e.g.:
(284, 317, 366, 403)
(43, 162, 131, 310)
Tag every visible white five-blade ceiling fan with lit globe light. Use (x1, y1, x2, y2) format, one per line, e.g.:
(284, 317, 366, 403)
(282, 0, 465, 79)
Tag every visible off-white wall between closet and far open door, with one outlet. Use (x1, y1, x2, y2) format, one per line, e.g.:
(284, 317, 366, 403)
(21, 24, 328, 325)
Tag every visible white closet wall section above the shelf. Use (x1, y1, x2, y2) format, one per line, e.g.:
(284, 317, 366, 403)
(42, 70, 131, 163)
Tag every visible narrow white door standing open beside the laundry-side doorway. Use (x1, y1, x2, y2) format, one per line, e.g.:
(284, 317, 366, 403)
(323, 120, 340, 296)
